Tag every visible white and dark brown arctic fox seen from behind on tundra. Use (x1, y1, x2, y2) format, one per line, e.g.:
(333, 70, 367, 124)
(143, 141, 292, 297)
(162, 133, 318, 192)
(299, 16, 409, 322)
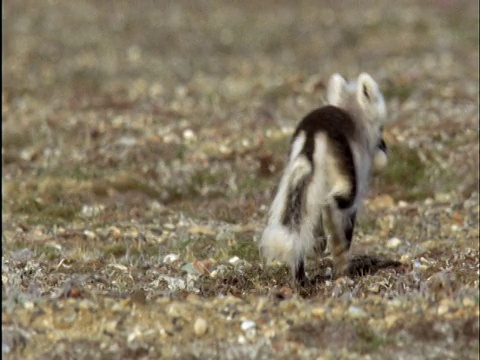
(260, 73, 387, 285)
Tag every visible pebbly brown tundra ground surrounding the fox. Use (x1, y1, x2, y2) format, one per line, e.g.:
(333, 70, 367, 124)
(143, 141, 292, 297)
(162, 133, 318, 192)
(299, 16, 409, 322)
(2, 0, 479, 359)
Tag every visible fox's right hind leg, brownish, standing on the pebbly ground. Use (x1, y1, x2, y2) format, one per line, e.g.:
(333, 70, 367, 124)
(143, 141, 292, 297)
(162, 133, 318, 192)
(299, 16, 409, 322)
(326, 205, 356, 276)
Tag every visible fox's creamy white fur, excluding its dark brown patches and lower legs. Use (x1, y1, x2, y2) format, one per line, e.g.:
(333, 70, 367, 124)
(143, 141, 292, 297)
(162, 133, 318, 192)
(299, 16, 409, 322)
(260, 73, 386, 280)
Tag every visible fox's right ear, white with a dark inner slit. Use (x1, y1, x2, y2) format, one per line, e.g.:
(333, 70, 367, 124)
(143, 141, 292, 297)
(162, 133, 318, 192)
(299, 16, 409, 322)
(356, 73, 386, 121)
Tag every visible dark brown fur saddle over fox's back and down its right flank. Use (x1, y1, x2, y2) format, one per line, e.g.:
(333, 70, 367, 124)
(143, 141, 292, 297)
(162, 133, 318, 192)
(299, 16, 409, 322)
(292, 105, 357, 209)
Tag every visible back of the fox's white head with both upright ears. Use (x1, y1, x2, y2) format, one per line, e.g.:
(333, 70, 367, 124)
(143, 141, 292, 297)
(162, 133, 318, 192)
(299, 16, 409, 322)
(327, 73, 387, 132)
